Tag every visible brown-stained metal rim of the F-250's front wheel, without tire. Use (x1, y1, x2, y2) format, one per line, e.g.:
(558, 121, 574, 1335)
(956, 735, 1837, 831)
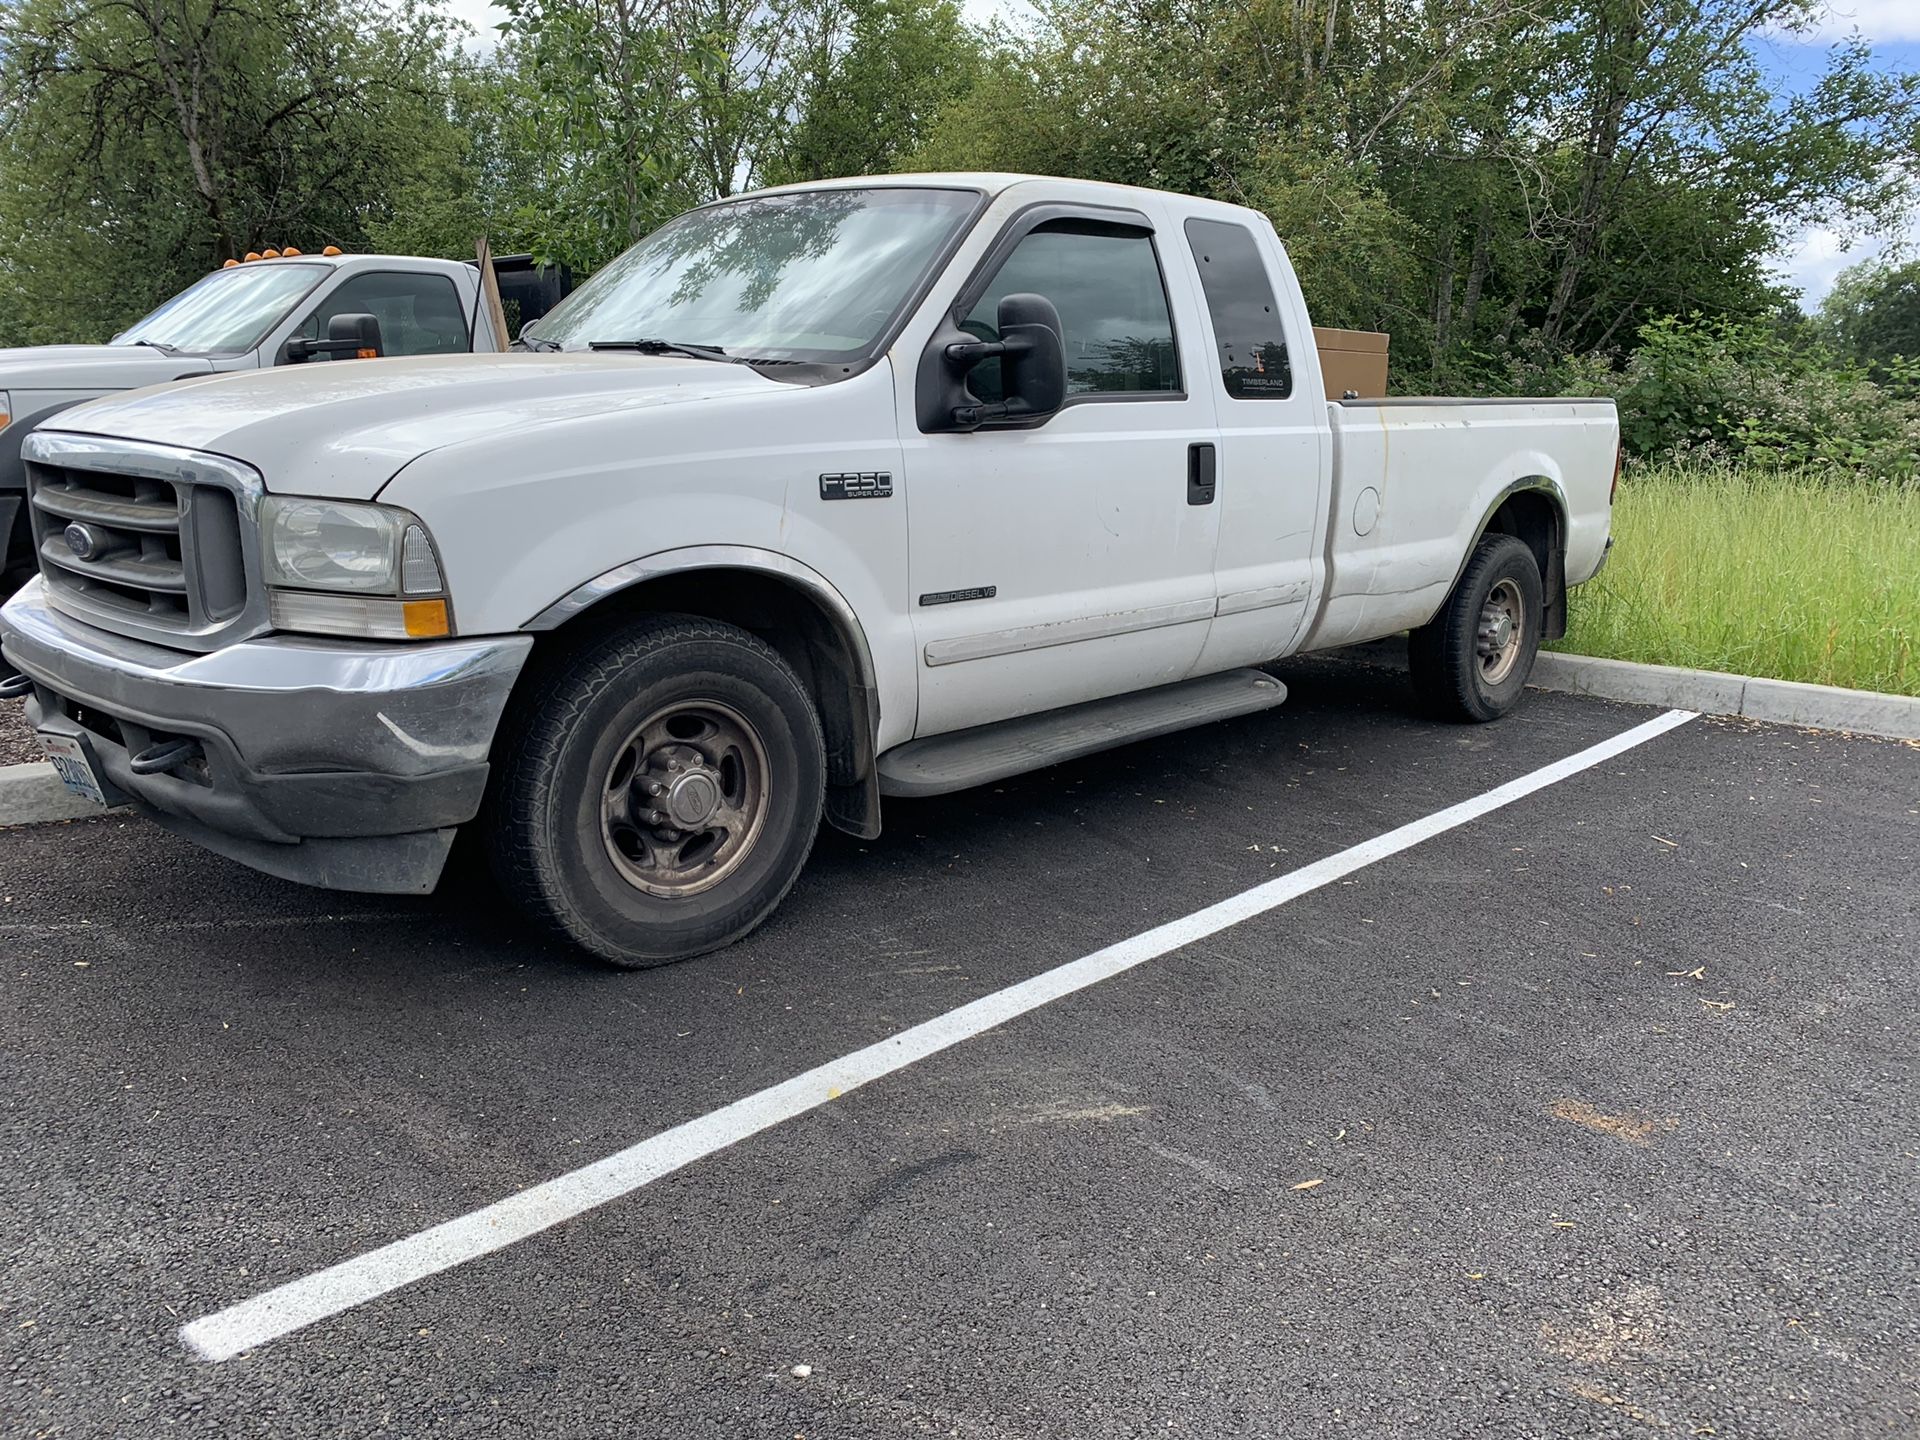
(601, 701, 766, 899)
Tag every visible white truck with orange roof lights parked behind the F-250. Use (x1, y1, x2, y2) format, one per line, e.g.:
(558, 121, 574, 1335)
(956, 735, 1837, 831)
(0, 246, 564, 595)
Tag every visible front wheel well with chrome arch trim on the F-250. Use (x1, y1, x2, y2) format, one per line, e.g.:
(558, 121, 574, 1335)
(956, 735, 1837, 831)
(534, 568, 879, 839)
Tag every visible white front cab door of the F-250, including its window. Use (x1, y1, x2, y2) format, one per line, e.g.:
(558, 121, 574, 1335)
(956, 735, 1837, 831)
(902, 204, 1219, 735)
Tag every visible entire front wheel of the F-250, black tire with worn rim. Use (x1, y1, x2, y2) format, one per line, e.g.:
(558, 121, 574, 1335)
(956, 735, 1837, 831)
(482, 618, 826, 968)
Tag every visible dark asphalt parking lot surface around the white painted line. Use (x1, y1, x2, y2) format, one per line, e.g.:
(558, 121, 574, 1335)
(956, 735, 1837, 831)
(0, 664, 1920, 1440)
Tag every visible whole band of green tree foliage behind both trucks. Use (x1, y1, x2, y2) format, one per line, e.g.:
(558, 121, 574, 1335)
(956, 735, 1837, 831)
(0, 0, 1920, 444)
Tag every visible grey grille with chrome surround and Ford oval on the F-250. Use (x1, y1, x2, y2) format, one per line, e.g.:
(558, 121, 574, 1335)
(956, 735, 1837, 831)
(21, 432, 265, 651)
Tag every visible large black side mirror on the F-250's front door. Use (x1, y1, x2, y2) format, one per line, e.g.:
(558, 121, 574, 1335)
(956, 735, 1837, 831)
(918, 294, 1068, 432)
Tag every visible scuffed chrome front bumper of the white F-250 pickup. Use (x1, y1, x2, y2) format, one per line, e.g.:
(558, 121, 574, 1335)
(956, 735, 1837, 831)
(0, 580, 534, 893)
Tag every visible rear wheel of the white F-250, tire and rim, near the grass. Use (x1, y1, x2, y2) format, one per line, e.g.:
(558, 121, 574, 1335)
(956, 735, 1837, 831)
(1407, 536, 1546, 720)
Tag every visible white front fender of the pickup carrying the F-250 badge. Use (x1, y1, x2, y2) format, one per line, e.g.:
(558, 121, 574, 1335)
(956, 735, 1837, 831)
(380, 365, 916, 743)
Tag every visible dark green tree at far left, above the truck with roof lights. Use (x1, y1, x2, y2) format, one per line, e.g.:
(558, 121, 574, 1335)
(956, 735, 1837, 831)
(0, 0, 457, 338)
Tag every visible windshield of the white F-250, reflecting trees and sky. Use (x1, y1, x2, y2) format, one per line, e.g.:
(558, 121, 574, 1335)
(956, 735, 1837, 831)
(522, 188, 979, 361)
